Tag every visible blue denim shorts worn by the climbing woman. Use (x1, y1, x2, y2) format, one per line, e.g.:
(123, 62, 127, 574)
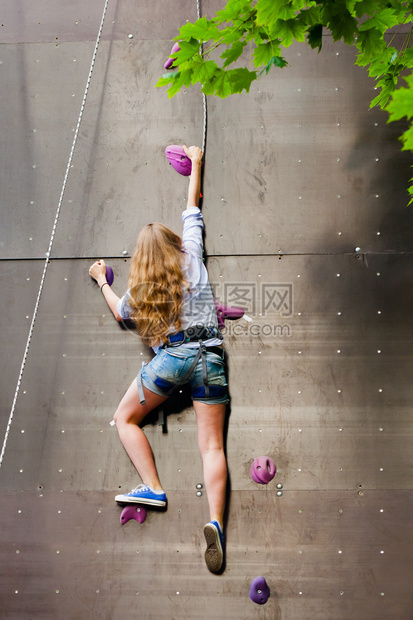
(142, 345, 229, 405)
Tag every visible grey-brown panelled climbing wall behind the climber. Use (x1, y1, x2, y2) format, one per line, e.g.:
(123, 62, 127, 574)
(0, 0, 413, 620)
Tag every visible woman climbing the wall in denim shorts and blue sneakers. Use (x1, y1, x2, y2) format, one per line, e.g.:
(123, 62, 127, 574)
(89, 146, 228, 572)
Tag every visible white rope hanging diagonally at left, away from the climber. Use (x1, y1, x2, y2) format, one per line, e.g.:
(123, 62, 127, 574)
(0, 0, 109, 468)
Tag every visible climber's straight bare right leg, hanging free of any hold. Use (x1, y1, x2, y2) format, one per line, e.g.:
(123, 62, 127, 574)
(194, 401, 228, 527)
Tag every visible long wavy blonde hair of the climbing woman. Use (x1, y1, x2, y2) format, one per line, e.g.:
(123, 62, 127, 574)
(129, 222, 189, 346)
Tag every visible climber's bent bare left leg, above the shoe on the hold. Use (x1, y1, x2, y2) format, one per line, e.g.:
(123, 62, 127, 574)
(114, 379, 167, 490)
